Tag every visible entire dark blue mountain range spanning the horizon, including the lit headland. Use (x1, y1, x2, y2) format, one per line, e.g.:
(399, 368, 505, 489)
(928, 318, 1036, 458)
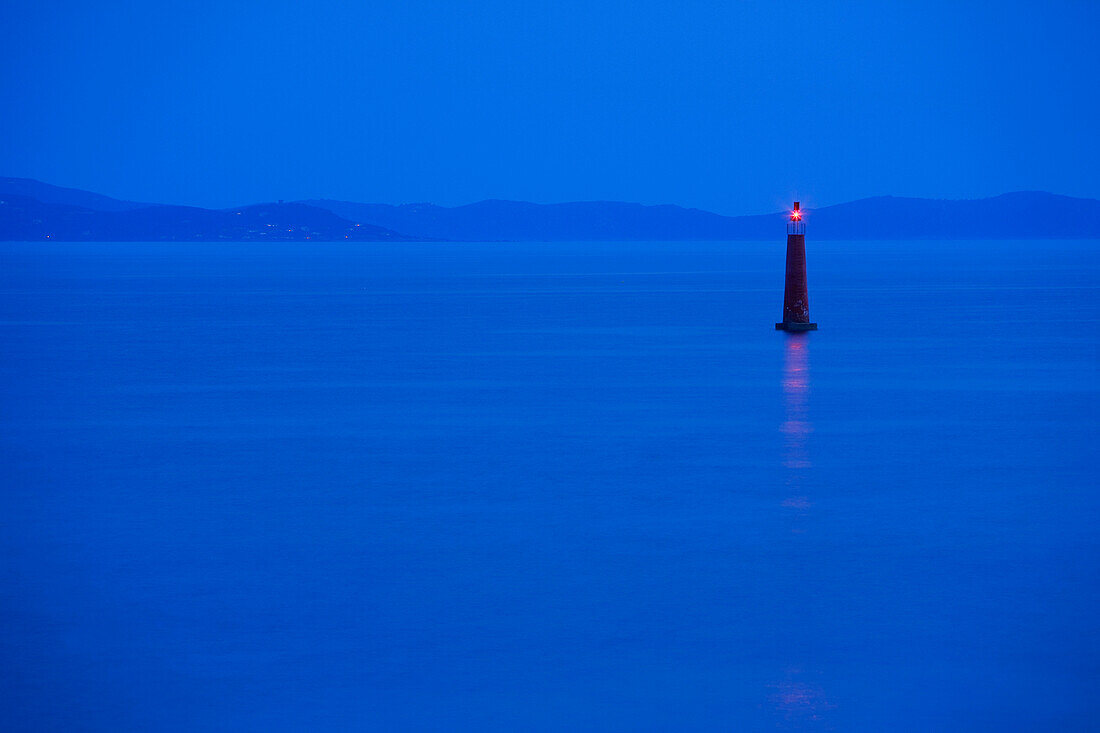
(0, 178, 1100, 241)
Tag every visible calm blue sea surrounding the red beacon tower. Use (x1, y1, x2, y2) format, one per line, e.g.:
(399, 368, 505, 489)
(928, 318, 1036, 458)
(0, 236, 1100, 733)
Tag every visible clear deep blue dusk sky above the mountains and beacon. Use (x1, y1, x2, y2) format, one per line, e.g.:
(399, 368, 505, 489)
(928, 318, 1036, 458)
(0, 0, 1100, 214)
